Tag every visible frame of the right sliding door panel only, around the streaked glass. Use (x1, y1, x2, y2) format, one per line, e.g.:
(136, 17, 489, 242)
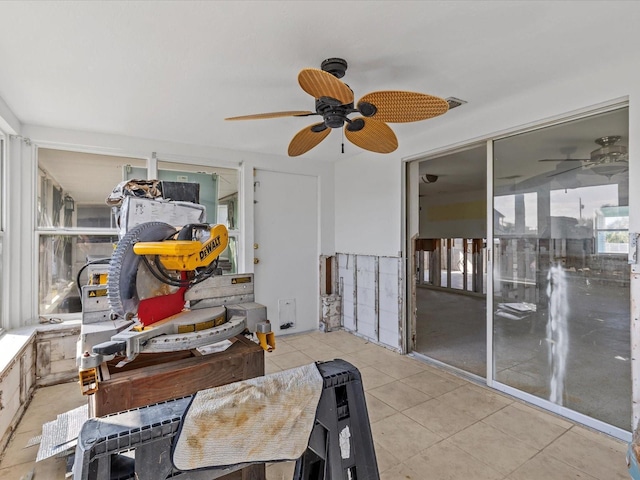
(486, 101, 640, 442)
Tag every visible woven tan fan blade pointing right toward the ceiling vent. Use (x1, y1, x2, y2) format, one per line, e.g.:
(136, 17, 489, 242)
(358, 90, 449, 123)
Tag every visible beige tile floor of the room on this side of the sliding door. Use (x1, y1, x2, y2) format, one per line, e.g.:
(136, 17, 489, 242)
(0, 331, 630, 480)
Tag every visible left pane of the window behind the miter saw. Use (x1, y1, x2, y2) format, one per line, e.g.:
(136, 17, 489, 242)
(37, 148, 146, 316)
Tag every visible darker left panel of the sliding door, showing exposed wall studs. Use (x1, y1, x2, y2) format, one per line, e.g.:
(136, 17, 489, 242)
(412, 142, 487, 378)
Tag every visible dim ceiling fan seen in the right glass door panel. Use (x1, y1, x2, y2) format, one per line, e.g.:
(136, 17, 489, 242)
(538, 135, 629, 178)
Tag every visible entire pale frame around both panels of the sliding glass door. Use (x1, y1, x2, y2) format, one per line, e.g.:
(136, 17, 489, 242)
(401, 97, 640, 442)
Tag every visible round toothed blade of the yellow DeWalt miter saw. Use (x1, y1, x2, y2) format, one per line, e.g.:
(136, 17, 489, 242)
(107, 222, 176, 318)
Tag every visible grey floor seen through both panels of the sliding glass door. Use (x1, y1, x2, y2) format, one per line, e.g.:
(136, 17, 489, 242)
(416, 284, 632, 429)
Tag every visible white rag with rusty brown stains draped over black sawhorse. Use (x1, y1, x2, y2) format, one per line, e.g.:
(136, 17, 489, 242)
(173, 364, 323, 470)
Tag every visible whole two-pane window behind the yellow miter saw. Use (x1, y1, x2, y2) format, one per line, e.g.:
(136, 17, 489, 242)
(36, 148, 240, 316)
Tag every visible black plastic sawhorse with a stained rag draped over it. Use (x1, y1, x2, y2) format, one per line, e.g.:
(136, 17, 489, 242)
(73, 360, 379, 480)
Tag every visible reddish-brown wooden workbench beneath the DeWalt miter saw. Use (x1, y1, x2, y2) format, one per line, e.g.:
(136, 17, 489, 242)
(89, 335, 265, 480)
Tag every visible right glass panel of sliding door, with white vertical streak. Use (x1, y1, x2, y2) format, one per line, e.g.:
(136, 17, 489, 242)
(493, 108, 632, 431)
